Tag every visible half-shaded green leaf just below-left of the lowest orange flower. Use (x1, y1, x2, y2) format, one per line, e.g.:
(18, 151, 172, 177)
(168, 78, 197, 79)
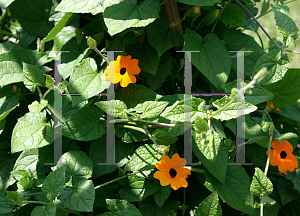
(118, 175, 158, 202)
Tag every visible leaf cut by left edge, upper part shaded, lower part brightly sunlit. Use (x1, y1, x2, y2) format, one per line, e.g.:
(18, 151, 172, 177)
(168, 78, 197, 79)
(0, 47, 45, 86)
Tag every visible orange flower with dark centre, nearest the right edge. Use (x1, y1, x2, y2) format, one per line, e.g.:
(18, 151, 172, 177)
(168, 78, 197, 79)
(267, 140, 298, 174)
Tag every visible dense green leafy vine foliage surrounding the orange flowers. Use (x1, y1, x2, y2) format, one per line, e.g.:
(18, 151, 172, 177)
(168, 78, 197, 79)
(0, 0, 300, 216)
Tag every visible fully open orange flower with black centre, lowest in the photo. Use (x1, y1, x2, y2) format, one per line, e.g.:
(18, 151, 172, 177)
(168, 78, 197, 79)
(153, 153, 191, 190)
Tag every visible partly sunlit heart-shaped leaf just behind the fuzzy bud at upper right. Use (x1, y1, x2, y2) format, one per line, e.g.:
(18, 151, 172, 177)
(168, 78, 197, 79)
(253, 50, 290, 85)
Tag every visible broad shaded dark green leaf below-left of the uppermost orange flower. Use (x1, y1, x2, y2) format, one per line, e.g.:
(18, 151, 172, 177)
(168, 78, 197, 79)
(62, 103, 106, 141)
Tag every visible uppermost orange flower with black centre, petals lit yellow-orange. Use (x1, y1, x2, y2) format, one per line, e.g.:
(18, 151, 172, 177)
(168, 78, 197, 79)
(104, 55, 141, 87)
